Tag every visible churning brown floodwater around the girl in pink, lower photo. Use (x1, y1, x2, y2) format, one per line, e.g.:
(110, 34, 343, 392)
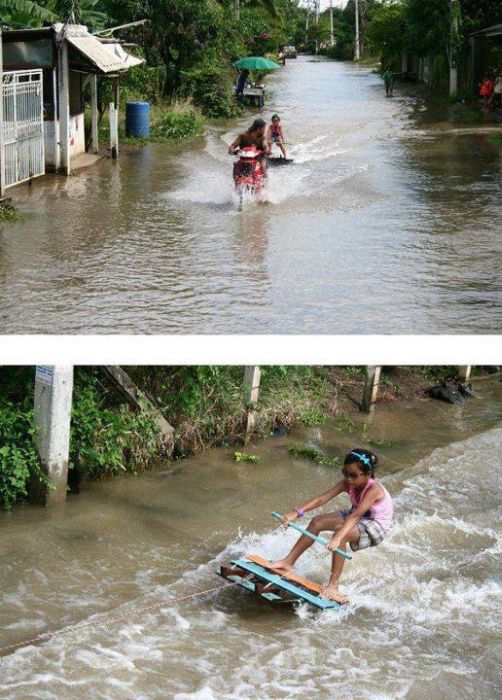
(0, 380, 502, 700)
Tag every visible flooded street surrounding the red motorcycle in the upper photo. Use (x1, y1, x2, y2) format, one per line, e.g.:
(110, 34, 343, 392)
(0, 57, 502, 334)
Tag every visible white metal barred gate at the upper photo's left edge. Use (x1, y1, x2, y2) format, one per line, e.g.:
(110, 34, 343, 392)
(0, 70, 45, 187)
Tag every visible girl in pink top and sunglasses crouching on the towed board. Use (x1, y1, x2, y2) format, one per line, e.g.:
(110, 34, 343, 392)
(272, 448, 394, 603)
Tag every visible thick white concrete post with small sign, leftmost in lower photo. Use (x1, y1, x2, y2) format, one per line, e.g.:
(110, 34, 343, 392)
(31, 365, 73, 506)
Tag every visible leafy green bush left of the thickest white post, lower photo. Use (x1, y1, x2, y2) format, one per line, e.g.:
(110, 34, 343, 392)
(0, 394, 48, 509)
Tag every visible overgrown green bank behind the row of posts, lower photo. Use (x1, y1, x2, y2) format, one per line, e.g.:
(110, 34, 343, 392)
(0, 366, 494, 508)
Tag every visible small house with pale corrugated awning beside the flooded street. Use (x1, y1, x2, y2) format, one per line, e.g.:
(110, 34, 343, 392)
(0, 23, 143, 189)
